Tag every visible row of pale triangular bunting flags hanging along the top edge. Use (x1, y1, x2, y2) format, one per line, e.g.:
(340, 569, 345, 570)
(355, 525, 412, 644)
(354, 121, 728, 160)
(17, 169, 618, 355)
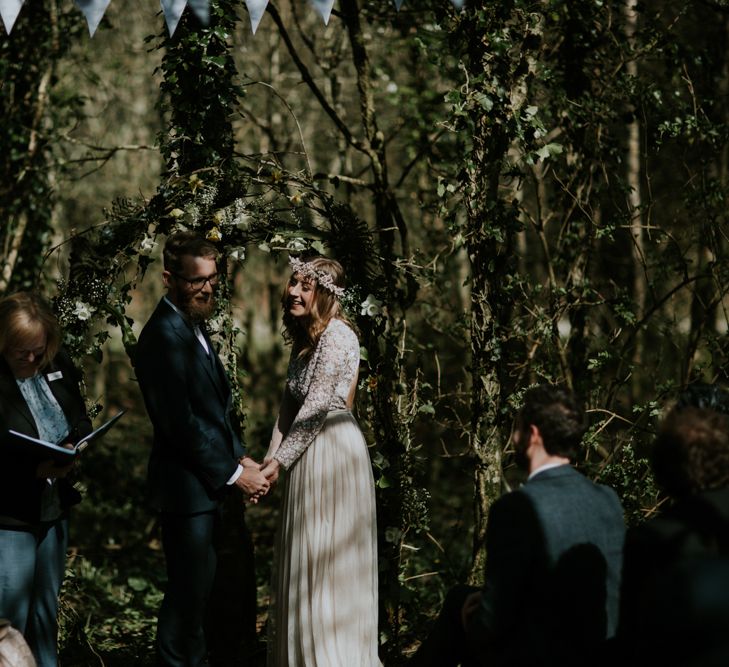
(0, 0, 465, 37)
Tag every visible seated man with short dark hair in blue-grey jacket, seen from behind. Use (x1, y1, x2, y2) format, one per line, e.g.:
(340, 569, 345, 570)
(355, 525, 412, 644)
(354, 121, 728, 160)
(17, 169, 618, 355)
(410, 385, 624, 667)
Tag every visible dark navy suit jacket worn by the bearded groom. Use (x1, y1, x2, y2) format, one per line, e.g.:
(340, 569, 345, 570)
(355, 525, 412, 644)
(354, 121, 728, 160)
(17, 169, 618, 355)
(135, 299, 244, 514)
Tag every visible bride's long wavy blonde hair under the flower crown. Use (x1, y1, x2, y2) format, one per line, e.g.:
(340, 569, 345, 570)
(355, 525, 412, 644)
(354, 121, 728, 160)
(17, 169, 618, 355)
(281, 257, 352, 357)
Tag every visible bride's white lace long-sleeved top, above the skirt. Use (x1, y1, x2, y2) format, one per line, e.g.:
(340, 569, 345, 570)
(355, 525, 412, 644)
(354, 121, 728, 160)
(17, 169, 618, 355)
(266, 319, 359, 469)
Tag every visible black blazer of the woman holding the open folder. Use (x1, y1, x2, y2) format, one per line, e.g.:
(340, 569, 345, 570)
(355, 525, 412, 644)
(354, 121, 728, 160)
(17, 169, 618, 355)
(0, 351, 91, 524)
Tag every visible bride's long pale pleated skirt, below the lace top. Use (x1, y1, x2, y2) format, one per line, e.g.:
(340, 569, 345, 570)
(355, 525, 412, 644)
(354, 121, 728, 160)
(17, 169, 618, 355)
(268, 410, 380, 667)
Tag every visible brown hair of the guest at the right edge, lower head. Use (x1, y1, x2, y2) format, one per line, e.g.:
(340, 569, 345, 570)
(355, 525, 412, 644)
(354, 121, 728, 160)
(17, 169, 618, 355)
(652, 406, 729, 497)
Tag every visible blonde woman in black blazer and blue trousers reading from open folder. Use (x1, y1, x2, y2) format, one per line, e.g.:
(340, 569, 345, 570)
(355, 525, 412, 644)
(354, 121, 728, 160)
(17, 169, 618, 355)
(0, 292, 91, 667)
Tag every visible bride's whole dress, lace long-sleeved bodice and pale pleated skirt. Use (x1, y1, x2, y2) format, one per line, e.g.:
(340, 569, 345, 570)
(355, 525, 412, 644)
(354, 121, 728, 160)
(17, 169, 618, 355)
(266, 319, 380, 667)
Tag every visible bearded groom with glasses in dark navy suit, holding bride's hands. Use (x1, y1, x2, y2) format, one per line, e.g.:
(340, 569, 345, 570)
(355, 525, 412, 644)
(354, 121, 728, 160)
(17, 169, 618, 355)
(135, 232, 270, 667)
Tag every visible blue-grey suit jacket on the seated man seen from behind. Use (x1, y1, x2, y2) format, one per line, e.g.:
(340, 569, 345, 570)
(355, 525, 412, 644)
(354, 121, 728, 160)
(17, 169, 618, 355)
(469, 465, 625, 667)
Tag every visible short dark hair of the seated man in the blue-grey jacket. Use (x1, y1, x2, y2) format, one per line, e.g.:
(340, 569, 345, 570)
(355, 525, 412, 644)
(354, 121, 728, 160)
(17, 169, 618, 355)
(519, 384, 586, 459)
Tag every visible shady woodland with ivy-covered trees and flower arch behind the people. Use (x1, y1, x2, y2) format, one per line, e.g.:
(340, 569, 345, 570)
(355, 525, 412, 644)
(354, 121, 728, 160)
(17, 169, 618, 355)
(0, 0, 729, 667)
